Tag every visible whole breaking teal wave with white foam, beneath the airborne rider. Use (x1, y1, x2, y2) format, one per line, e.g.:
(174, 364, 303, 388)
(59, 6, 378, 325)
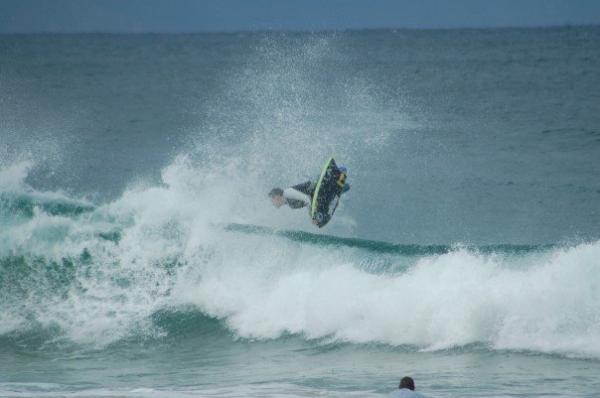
(0, 159, 600, 358)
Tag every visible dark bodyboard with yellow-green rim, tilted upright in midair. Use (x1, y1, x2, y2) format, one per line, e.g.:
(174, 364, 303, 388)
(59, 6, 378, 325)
(310, 157, 346, 228)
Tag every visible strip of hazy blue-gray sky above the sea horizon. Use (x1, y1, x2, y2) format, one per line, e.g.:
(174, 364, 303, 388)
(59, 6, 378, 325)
(0, 0, 600, 33)
